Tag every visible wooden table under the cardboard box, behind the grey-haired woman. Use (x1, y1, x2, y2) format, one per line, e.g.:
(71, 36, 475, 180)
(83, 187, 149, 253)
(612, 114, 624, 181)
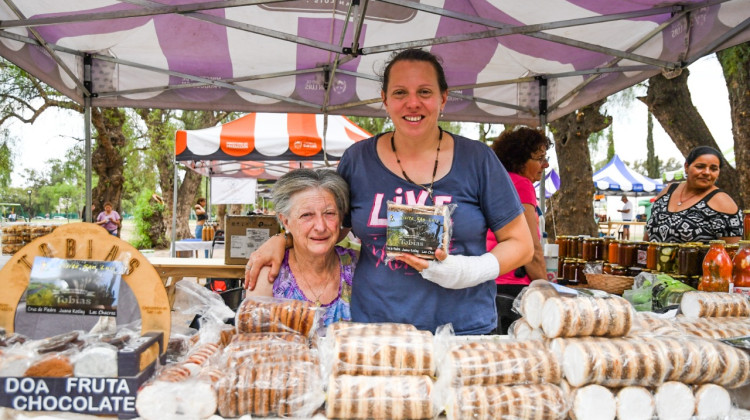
(149, 257, 245, 306)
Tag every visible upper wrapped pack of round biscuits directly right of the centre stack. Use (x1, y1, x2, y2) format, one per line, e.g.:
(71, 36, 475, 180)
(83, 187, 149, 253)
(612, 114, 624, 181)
(439, 340, 562, 386)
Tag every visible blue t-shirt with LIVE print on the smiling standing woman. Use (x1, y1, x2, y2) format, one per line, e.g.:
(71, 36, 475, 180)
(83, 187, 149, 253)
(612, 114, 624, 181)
(338, 135, 523, 334)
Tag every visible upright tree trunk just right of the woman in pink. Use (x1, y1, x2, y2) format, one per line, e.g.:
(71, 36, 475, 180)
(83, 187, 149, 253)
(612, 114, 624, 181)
(545, 100, 611, 240)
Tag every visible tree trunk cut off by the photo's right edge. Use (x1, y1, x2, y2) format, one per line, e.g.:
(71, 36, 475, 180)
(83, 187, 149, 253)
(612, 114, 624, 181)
(716, 42, 750, 209)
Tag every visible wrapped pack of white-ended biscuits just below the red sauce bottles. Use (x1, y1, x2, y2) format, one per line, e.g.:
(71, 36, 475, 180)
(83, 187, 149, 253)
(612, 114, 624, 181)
(680, 291, 750, 318)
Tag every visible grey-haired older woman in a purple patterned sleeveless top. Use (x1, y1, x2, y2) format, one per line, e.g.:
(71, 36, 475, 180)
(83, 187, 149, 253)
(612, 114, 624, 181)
(246, 169, 357, 325)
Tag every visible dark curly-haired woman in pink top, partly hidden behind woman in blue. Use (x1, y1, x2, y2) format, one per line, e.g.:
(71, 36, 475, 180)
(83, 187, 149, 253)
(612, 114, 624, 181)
(487, 127, 553, 297)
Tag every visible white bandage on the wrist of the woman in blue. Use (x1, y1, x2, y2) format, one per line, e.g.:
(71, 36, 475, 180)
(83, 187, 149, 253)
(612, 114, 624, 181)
(422, 252, 500, 289)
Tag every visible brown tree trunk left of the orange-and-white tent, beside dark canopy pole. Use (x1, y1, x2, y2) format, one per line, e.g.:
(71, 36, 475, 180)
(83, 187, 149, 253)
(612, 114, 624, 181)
(91, 107, 128, 218)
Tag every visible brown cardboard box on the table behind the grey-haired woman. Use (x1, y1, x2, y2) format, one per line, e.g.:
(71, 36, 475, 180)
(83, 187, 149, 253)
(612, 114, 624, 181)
(224, 215, 281, 265)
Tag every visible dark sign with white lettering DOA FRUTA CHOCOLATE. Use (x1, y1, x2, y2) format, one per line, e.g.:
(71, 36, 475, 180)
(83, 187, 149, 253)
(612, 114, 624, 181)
(0, 378, 138, 415)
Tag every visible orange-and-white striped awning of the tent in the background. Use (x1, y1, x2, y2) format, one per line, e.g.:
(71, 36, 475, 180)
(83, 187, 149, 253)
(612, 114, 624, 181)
(175, 113, 371, 178)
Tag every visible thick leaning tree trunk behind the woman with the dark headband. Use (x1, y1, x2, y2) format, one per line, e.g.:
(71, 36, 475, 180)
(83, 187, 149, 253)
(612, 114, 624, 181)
(638, 69, 740, 204)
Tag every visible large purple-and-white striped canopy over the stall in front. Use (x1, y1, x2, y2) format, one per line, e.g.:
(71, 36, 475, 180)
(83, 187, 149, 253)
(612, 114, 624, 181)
(0, 0, 750, 124)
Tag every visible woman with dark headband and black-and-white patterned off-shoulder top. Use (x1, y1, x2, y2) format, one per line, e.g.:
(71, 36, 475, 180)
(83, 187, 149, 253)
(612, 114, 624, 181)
(644, 146, 742, 242)
